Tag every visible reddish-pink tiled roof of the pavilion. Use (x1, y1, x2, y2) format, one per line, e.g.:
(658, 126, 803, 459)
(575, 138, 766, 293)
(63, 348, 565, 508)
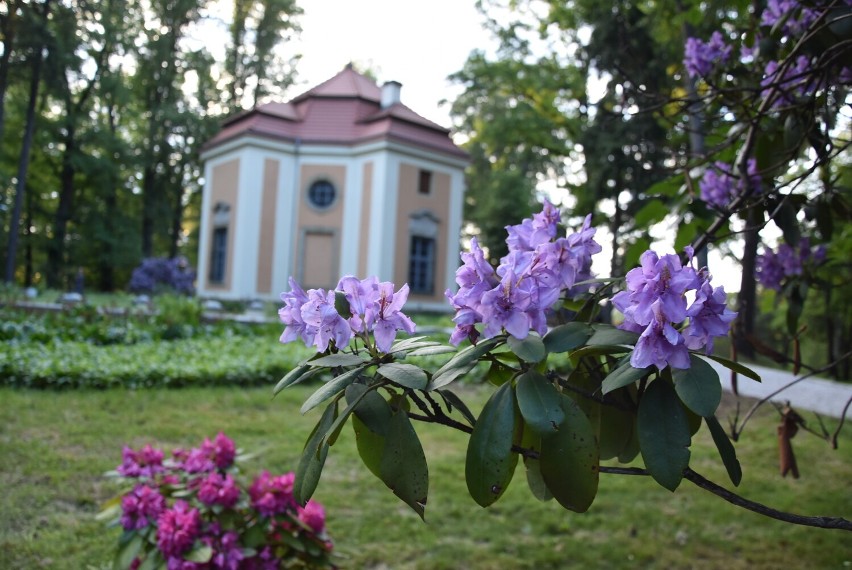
(205, 65, 468, 158)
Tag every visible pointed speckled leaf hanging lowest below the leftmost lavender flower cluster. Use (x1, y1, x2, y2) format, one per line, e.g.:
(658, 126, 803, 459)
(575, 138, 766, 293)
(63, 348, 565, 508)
(380, 410, 429, 519)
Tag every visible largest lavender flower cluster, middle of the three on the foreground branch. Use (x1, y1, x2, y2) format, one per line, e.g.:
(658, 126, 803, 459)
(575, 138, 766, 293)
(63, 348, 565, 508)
(446, 201, 601, 345)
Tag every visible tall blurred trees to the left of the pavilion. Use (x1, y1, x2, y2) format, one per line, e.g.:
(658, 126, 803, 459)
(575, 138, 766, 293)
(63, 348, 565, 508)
(0, 0, 301, 290)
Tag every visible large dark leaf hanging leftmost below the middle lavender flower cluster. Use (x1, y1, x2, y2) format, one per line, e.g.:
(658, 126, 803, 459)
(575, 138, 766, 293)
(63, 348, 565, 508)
(465, 382, 518, 507)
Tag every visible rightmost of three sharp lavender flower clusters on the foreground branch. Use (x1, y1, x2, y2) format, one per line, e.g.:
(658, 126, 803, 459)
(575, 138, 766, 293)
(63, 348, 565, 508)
(612, 250, 736, 370)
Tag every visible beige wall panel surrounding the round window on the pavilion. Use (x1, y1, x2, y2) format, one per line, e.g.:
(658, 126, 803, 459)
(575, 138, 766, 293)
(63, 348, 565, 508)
(294, 164, 346, 288)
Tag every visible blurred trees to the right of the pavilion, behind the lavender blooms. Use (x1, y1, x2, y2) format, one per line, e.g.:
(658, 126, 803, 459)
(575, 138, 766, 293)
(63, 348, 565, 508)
(452, 0, 852, 377)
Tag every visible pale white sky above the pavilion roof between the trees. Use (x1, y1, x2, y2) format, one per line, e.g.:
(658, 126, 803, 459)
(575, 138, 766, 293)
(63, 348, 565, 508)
(288, 0, 493, 127)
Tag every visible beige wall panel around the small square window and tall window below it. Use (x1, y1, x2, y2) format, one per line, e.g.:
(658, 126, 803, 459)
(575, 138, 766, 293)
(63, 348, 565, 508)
(394, 163, 450, 302)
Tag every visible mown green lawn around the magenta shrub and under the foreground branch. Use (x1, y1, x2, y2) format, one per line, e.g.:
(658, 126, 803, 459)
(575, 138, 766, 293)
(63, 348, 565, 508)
(0, 386, 852, 570)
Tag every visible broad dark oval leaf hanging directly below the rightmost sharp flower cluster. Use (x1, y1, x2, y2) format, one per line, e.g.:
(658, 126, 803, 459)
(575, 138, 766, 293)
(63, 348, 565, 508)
(637, 379, 692, 491)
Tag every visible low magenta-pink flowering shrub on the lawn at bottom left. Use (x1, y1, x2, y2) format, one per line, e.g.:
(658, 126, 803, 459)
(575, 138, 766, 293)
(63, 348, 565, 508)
(101, 433, 334, 570)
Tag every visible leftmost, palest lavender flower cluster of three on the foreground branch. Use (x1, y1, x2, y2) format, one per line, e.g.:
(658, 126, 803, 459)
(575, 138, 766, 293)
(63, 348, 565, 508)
(278, 275, 415, 352)
